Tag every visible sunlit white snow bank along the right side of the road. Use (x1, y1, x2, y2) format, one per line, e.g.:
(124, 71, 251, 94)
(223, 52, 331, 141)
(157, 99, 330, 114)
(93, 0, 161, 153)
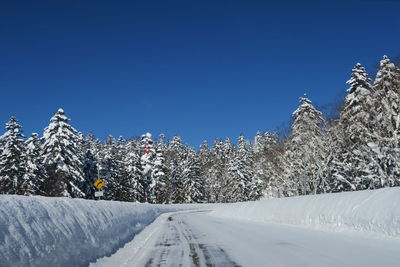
(212, 187, 400, 238)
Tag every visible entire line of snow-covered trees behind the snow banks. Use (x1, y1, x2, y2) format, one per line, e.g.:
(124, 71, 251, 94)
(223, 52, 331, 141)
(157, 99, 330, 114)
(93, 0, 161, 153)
(0, 56, 400, 203)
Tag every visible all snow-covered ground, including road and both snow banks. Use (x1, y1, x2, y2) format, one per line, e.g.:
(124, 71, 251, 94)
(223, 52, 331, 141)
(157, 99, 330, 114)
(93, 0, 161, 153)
(0, 188, 400, 267)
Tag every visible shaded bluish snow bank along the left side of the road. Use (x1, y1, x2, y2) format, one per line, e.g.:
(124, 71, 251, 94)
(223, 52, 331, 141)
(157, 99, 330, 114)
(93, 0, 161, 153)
(0, 195, 187, 267)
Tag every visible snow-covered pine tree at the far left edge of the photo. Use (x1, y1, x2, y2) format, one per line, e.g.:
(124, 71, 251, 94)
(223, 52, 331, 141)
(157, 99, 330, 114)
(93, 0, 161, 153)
(0, 116, 28, 195)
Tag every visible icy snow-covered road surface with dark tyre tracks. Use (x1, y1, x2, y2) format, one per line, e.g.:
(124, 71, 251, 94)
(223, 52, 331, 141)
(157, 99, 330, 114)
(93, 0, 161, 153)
(91, 211, 400, 267)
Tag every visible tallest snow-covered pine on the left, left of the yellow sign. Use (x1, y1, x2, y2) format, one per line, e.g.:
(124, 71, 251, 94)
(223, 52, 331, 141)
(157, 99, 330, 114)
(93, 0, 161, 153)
(41, 109, 85, 197)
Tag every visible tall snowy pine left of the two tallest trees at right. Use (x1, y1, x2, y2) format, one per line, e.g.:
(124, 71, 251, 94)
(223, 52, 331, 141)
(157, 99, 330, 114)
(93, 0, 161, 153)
(287, 96, 326, 195)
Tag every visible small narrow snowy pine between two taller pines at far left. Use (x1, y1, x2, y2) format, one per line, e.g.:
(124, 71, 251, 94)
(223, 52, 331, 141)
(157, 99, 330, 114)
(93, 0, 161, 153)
(25, 133, 46, 195)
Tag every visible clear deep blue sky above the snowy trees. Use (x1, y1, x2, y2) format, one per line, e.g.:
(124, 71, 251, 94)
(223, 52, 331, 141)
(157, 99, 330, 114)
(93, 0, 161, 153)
(0, 0, 400, 147)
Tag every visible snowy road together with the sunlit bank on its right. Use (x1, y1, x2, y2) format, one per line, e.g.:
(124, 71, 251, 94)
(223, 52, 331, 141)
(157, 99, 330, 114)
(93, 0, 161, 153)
(91, 188, 400, 267)
